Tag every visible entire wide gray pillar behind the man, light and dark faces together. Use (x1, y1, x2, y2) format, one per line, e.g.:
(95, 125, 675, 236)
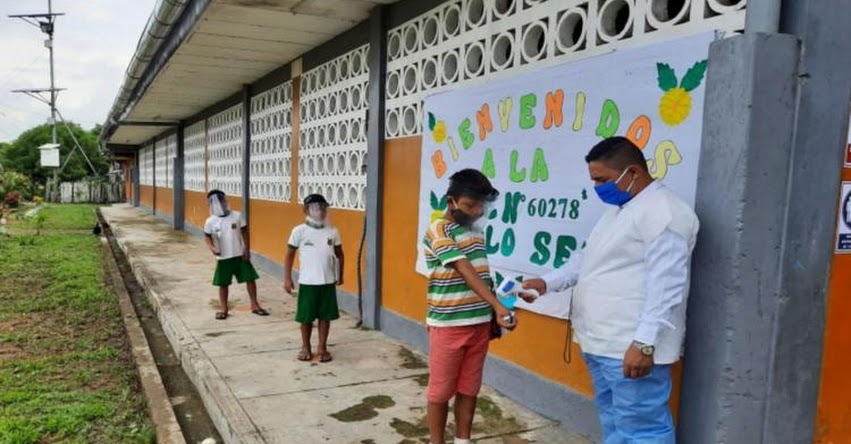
(679, 0, 851, 438)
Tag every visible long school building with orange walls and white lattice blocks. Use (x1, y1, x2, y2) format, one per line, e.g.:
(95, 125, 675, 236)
(103, 0, 851, 444)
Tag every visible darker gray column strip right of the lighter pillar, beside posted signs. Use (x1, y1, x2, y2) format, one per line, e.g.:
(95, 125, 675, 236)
(763, 0, 851, 444)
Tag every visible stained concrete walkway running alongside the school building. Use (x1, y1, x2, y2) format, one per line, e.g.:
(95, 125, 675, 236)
(102, 205, 589, 444)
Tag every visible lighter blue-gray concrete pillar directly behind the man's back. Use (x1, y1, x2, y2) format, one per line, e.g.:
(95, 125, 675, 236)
(679, 34, 798, 444)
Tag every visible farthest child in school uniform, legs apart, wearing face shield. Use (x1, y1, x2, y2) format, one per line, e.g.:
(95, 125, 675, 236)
(204, 190, 269, 320)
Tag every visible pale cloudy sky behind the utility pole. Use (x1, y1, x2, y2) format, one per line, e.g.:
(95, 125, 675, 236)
(0, 0, 156, 142)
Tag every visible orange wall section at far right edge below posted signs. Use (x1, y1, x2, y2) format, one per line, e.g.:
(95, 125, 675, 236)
(814, 169, 851, 444)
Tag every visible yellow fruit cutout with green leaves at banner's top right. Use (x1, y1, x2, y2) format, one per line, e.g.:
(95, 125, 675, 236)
(656, 60, 707, 126)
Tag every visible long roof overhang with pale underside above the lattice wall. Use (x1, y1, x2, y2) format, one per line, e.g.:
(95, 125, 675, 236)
(104, 0, 395, 145)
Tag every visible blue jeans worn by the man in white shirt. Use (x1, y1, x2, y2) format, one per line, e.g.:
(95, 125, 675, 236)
(582, 354, 676, 444)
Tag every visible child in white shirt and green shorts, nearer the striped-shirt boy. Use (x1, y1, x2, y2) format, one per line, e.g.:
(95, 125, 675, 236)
(284, 194, 343, 362)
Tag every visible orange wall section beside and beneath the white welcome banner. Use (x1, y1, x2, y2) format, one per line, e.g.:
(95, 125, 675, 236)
(381, 136, 680, 406)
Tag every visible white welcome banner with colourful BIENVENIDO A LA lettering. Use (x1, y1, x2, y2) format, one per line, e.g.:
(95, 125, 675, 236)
(417, 34, 714, 317)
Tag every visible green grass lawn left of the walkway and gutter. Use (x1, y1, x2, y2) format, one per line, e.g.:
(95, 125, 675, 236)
(0, 205, 154, 444)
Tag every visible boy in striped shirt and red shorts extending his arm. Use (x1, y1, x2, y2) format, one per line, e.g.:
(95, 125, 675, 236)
(423, 169, 515, 444)
